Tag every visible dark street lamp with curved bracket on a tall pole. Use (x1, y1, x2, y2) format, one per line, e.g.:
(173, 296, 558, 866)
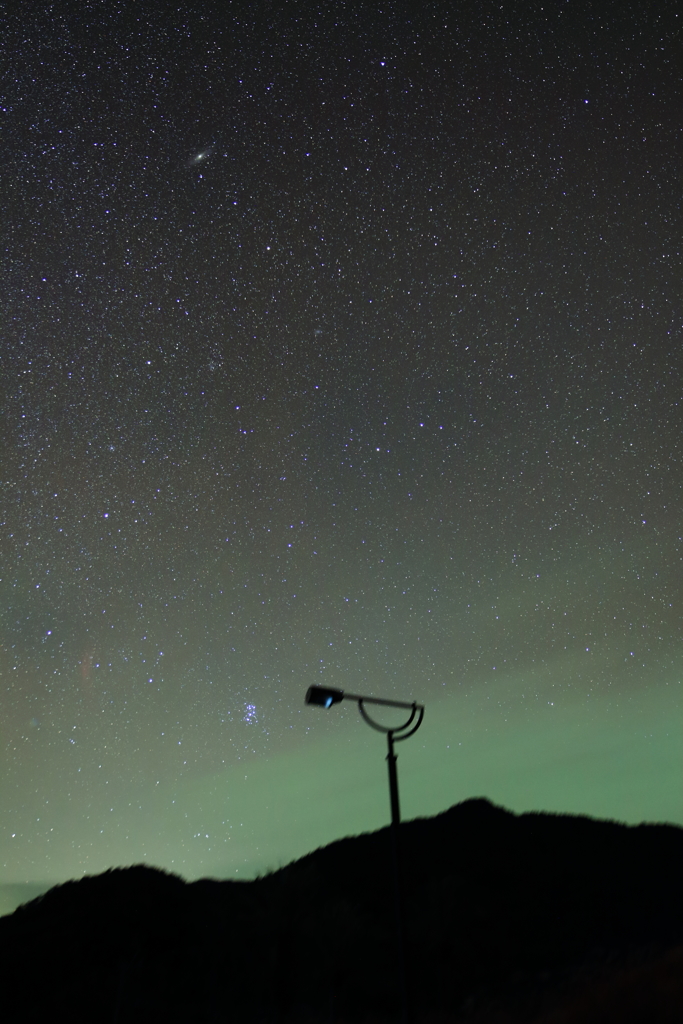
(306, 686, 425, 1024)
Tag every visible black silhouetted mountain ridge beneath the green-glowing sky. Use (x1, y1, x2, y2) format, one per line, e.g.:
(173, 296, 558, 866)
(0, 800, 683, 1024)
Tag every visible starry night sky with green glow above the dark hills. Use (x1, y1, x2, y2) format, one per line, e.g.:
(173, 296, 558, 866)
(0, 0, 683, 908)
